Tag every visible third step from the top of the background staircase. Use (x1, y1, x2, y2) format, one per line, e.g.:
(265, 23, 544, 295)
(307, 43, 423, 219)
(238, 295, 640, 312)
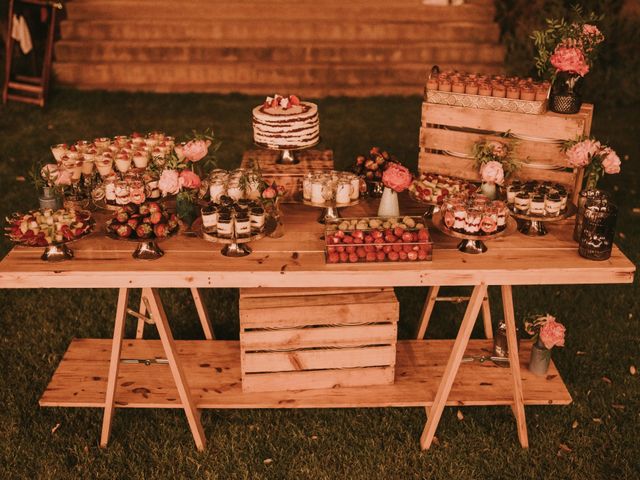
(55, 40, 504, 65)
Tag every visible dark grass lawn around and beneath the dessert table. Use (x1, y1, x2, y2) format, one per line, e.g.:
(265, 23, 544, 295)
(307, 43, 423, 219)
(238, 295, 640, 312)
(0, 90, 640, 479)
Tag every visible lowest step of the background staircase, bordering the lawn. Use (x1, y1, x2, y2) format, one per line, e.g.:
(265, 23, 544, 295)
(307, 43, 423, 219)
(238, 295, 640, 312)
(54, 62, 502, 97)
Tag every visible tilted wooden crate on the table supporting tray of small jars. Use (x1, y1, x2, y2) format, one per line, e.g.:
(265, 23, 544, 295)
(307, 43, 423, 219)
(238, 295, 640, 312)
(418, 102, 593, 203)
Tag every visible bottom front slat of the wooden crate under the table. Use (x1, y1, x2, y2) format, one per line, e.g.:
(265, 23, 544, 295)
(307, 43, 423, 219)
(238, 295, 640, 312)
(242, 367, 394, 392)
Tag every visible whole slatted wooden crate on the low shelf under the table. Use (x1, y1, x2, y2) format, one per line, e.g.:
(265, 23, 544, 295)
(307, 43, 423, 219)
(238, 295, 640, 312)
(240, 288, 399, 392)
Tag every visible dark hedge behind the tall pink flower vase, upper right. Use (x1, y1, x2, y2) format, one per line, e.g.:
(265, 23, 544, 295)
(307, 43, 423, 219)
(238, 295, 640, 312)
(496, 0, 640, 104)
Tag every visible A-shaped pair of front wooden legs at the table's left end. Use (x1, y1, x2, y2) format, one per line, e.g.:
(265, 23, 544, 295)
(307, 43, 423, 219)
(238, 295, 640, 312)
(100, 288, 206, 451)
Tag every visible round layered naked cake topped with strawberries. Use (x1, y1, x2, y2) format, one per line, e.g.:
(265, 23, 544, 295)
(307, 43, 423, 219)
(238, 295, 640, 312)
(253, 95, 320, 150)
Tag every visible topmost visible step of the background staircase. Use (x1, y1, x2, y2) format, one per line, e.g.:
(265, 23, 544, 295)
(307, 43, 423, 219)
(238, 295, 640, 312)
(66, 0, 495, 21)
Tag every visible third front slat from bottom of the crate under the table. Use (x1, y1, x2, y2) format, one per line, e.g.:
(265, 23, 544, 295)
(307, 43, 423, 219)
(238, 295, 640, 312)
(240, 323, 398, 350)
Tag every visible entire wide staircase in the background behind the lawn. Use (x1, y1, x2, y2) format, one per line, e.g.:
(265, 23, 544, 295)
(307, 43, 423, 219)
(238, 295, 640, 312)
(54, 0, 504, 97)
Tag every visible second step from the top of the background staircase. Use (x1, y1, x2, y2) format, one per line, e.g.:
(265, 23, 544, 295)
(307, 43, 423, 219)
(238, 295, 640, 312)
(60, 18, 500, 43)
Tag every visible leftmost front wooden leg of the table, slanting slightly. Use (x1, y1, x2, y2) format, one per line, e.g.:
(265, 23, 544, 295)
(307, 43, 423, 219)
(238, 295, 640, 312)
(100, 288, 129, 447)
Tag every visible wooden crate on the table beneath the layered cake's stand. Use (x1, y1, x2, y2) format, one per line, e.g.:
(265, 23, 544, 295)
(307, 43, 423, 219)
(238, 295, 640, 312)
(242, 150, 333, 202)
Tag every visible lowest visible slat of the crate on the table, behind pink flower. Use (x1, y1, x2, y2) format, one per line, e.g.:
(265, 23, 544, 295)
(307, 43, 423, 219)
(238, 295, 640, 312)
(418, 149, 576, 191)
